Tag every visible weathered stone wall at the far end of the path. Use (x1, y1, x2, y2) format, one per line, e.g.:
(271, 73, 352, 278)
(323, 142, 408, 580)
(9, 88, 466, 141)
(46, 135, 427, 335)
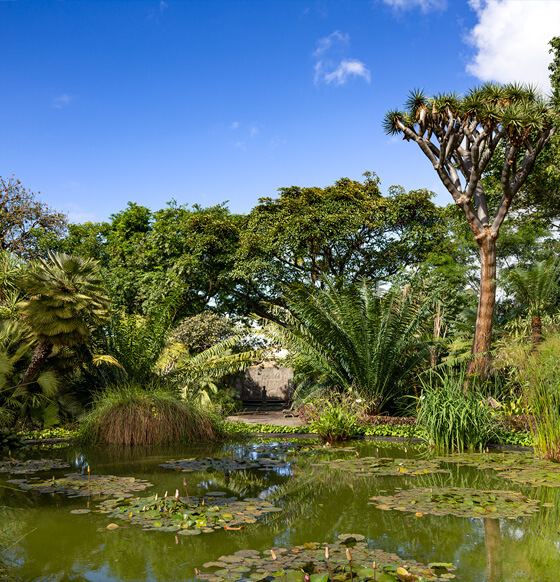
(235, 366, 294, 402)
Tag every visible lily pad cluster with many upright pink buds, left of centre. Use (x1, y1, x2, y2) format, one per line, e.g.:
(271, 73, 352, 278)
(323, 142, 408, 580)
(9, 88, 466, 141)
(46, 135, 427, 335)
(98, 495, 281, 532)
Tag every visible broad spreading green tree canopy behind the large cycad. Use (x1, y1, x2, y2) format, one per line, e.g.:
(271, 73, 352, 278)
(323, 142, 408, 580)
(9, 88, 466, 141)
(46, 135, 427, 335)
(234, 173, 444, 304)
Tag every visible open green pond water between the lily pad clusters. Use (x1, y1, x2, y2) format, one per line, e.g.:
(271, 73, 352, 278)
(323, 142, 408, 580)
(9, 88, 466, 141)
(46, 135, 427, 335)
(0, 439, 560, 582)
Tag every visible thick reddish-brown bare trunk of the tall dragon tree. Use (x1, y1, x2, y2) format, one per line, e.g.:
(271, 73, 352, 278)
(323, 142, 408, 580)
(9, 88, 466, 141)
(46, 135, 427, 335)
(467, 235, 497, 378)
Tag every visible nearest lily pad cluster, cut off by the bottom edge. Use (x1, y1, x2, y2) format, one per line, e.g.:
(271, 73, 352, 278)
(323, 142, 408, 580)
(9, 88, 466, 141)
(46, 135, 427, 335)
(197, 534, 455, 582)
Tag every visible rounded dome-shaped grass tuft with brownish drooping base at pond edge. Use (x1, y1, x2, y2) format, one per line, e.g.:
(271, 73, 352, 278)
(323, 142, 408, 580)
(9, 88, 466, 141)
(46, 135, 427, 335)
(79, 384, 216, 445)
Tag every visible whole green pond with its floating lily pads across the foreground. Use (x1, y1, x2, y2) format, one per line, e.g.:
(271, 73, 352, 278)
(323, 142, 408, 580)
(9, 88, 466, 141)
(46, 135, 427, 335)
(0, 438, 560, 582)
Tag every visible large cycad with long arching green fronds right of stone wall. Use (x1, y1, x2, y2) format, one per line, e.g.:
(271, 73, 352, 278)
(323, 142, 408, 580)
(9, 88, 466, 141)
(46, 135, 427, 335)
(258, 280, 432, 412)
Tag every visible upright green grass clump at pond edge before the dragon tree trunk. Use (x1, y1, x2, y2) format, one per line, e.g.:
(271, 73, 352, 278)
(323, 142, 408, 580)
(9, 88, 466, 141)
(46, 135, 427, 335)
(417, 367, 493, 451)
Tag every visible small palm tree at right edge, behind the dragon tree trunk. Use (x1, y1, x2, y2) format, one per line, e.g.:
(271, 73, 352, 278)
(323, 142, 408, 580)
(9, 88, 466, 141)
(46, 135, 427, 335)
(506, 258, 560, 344)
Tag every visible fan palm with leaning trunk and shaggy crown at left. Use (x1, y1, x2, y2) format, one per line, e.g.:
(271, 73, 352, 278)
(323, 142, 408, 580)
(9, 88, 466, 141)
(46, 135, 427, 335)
(19, 252, 109, 384)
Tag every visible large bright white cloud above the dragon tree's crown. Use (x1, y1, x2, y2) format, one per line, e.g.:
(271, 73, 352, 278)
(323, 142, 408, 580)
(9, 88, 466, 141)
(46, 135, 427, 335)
(466, 0, 560, 92)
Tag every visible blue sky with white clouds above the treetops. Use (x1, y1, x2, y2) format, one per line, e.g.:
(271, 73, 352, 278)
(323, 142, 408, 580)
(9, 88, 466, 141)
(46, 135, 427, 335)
(0, 0, 560, 222)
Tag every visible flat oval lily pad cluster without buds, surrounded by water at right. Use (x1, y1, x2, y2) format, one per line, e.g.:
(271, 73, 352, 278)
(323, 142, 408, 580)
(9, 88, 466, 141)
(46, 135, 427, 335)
(370, 487, 539, 519)
